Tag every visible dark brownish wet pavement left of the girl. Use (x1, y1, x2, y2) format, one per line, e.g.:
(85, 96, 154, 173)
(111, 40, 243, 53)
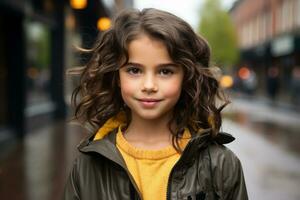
(0, 122, 84, 200)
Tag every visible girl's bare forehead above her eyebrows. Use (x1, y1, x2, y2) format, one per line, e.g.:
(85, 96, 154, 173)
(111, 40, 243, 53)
(128, 34, 172, 62)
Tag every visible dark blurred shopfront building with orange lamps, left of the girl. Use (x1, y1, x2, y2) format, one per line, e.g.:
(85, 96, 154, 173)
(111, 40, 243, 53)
(0, 0, 133, 148)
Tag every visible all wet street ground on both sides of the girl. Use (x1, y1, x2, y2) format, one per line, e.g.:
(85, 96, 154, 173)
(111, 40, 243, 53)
(0, 96, 300, 200)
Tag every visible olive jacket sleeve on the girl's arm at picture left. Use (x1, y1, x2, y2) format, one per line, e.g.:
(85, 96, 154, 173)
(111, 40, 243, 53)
(63, 159, 80, 200)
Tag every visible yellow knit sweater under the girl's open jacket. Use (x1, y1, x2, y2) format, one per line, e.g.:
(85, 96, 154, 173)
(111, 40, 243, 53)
(116, 128, 191, 200)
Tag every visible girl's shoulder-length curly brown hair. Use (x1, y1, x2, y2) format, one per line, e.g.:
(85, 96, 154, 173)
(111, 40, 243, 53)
(72, 8, 228, 151)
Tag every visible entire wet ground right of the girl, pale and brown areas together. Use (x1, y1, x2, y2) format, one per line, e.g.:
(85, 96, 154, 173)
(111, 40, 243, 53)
(223, 96, 300, 200)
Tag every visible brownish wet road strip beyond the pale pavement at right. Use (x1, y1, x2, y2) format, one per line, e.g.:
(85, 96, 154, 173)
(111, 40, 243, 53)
(224, 99, 300, 158)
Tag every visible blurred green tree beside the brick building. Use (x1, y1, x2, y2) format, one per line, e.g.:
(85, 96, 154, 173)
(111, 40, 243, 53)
(198, 0, 239, 69)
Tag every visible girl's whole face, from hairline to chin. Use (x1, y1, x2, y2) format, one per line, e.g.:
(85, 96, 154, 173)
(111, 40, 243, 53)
(119, 35, 184, 120)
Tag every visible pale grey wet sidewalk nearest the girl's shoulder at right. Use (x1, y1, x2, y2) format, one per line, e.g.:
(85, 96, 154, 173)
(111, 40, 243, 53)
(223, 120, 300, 200)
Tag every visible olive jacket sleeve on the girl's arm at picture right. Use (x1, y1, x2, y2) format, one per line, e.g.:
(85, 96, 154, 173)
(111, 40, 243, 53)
(225, 154, 248, 200)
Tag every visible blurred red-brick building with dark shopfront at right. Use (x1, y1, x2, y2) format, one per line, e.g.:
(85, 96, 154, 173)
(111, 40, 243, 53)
(230, 0, 300, 101)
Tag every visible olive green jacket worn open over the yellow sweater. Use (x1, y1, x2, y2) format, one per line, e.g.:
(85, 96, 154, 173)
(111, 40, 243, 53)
(64, 126, 248, 200)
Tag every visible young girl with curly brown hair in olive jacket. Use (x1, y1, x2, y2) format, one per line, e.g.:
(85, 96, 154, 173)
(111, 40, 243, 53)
(65, 9, 248, 200)
